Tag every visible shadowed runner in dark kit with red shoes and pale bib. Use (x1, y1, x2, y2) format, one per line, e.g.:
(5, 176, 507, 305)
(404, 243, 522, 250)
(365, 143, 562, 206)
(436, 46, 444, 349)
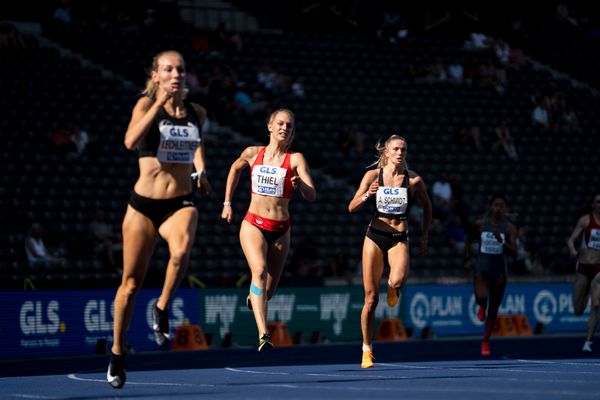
(465, 194, 517, 356)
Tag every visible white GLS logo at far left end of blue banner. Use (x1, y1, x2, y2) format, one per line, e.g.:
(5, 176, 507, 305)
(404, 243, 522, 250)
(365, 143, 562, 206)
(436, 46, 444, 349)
(19, 300, 66, 348)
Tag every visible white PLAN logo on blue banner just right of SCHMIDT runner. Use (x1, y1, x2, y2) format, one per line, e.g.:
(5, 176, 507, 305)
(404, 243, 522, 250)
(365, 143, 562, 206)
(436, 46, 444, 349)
(410, 292, 463, 329)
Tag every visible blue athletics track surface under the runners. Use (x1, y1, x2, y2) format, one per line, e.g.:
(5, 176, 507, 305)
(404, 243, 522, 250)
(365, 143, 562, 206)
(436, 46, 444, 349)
(0, 336, 600, 400)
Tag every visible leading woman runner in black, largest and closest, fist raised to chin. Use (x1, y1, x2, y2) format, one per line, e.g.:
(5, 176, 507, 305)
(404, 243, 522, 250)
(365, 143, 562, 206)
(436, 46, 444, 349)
(107, 51, 211, 388)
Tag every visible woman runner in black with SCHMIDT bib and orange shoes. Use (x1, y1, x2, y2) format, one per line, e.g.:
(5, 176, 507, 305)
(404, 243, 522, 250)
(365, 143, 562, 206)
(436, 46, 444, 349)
(348, 135, 431, 368)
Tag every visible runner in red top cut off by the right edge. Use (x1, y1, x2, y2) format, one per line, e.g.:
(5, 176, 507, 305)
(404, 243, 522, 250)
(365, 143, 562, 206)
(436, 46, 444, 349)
(567, 192, 600, 352)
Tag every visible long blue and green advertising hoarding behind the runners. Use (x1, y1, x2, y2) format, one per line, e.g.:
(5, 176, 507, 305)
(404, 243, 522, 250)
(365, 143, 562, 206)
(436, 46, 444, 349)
(0, 283, 589, 357)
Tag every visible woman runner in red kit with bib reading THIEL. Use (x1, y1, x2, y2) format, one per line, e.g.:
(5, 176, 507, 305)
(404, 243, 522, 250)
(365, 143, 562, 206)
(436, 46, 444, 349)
(221, 109, 317, 352)
